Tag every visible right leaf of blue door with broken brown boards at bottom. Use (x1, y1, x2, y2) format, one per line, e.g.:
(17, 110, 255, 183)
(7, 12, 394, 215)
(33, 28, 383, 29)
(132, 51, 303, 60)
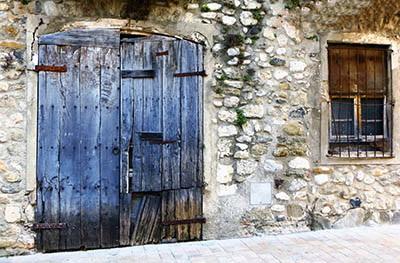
(121, 37, 203, 244)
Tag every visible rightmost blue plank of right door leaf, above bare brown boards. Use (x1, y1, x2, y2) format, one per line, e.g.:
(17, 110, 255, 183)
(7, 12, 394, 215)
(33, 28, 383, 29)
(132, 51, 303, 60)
(181, 41, 199, 188)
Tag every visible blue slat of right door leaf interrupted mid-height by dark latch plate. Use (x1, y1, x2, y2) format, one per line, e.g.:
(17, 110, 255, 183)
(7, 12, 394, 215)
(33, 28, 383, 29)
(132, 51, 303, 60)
(142, 41, 162, 192)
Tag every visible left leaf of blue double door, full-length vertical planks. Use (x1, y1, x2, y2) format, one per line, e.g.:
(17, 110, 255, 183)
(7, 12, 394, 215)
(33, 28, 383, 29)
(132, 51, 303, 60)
(36, 31, 120, 251)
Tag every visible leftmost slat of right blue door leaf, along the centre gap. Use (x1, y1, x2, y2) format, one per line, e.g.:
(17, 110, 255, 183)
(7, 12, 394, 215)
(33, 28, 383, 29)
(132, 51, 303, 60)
(120, 43, 135, 246)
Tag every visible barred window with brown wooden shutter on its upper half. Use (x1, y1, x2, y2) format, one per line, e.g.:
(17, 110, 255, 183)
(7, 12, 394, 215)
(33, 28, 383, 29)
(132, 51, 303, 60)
(328, 44, 393, 158)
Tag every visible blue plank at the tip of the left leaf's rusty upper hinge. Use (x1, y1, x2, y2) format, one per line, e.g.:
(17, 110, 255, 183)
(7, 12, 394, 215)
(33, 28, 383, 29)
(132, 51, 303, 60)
(60, 46, 81, 250)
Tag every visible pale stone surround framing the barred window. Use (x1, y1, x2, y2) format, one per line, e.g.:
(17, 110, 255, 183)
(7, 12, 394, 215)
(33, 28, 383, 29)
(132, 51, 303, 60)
(319, 33, 400, 165)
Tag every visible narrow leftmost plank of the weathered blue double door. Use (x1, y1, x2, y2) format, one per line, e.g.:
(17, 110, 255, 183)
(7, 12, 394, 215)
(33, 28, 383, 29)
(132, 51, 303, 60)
(35, 45, 47, 251)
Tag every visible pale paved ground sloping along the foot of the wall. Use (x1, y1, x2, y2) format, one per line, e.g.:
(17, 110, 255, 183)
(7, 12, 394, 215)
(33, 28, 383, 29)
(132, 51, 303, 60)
(0, 225, 400, 263)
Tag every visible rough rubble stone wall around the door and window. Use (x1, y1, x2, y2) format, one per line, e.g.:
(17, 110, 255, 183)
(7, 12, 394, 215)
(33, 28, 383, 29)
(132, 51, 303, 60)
(0, 0, 400, 256)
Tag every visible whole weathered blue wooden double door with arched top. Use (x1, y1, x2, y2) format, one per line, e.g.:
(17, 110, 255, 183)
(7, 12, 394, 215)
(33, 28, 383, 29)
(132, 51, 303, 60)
(34, 30, 204, 251)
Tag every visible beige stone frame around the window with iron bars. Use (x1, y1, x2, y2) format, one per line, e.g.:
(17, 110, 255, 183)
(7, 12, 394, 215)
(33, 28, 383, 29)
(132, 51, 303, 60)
(318, 33, 400, 165)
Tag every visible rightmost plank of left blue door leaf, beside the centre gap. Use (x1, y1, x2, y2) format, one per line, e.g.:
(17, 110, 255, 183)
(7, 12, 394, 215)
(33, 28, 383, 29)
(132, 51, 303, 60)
(100, 48, 120, 248)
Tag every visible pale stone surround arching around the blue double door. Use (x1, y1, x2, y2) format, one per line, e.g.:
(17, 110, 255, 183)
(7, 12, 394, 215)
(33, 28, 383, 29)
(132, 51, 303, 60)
(25, 15, 217, 194)
